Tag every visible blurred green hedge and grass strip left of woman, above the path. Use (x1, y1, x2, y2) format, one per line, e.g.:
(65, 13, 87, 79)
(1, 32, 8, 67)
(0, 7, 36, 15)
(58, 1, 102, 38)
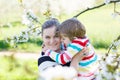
(0, 38, 43, 52)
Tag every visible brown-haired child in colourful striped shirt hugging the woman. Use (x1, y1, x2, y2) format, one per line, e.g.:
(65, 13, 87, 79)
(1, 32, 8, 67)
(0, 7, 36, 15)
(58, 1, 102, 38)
(45, 18, 98, 80)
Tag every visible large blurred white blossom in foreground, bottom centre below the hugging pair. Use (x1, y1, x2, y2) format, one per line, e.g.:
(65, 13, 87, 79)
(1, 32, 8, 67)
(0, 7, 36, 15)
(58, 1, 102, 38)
(40, 66, 77, 80)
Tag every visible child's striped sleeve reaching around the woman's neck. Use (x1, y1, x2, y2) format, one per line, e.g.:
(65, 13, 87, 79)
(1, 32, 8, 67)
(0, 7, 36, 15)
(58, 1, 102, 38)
(45, 40, 88, 64)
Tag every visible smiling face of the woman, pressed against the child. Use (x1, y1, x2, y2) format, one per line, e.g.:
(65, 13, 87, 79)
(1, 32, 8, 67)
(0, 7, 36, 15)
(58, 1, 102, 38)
(42, 26, 61, 51)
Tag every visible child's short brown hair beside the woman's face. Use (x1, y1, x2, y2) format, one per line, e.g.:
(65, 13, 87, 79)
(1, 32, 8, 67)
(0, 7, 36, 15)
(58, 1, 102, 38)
(59, 18, 86, 40)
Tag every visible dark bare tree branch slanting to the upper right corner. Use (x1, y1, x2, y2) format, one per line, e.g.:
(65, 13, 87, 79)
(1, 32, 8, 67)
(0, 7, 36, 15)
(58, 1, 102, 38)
(73, 0, 120, 18)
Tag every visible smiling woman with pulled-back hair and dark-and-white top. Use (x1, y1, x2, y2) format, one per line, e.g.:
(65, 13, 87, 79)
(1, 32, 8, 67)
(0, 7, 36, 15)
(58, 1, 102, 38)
(38, 19, 70, 71)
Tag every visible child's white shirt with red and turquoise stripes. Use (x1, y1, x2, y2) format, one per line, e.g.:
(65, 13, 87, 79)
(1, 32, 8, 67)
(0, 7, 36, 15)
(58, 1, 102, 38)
(45, 37, 98, 80)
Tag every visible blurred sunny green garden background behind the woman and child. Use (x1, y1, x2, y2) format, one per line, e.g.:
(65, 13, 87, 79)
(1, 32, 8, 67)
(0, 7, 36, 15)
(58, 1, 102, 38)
(0, 0, 120, 80)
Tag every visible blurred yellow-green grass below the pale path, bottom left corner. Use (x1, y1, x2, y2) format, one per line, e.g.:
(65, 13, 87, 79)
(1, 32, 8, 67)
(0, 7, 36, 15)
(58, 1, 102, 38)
(0, 56, 38, 80)
